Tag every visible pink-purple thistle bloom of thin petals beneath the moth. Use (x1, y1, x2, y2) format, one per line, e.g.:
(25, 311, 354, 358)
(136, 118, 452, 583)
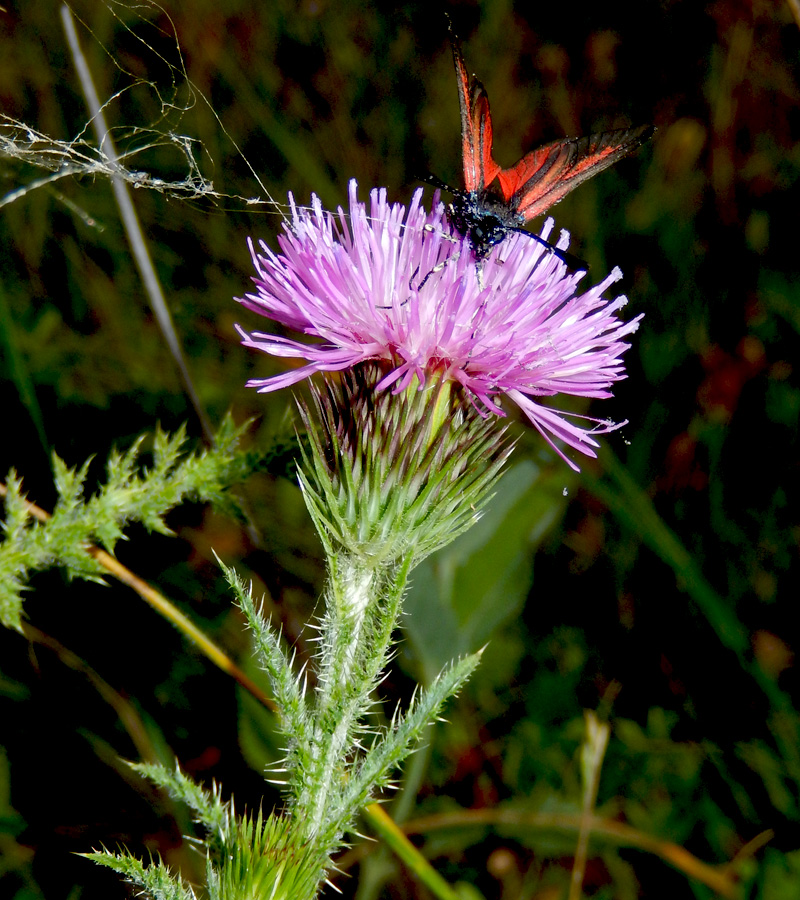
(237, 181, 642, 469)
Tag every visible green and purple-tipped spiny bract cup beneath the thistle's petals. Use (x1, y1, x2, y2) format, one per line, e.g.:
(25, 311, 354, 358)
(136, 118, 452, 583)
(299, 363, 511, 565)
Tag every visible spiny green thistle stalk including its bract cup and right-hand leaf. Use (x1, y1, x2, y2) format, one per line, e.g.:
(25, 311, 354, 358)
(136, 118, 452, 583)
(290, 364, 510, 860)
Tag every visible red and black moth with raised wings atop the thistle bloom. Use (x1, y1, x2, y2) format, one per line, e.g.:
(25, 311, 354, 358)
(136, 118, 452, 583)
(424, 29, 655, 262)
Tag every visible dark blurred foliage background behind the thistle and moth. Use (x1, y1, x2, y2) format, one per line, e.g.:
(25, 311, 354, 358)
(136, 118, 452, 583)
(0, 0, 800, 900)
